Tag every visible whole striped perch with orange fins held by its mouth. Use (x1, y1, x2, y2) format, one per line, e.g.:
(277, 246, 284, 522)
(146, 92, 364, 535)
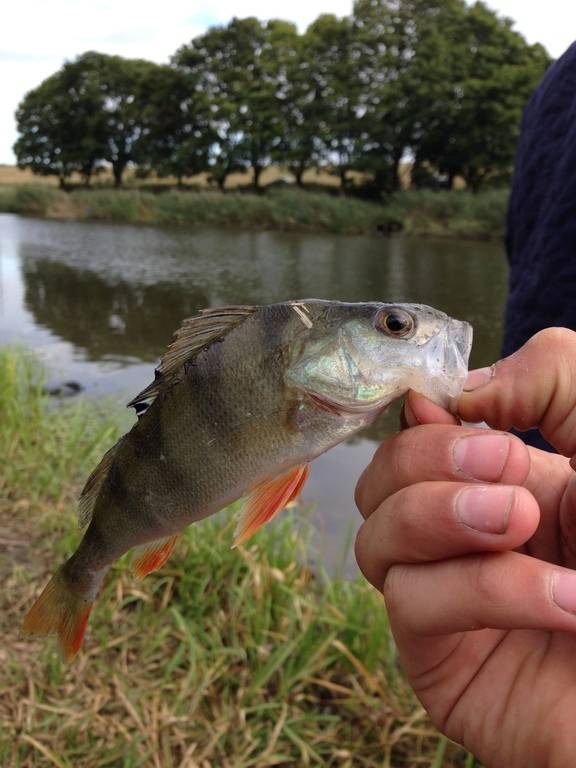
(23, 299, 472, 659)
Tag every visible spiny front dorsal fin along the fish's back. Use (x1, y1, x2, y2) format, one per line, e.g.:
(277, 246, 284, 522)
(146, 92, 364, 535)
(128, 306, 259, 415)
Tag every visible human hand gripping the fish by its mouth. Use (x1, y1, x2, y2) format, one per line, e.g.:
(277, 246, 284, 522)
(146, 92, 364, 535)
(356, 329, 576, 768)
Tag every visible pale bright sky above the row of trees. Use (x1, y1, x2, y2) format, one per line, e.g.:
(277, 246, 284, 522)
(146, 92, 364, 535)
(0, 0, 576, 164)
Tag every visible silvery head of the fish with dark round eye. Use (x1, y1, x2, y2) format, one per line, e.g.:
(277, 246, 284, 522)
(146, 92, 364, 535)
(288, 302, 472, 417)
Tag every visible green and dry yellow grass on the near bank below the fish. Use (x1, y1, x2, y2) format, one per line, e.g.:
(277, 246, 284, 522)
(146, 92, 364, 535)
(0, 349, 473, 768)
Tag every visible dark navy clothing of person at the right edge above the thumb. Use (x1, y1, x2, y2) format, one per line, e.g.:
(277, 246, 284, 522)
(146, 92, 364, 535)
(504, 43, 576, 355)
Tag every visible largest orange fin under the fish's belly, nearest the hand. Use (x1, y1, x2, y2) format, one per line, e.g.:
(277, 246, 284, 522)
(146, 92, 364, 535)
(232, 464, 310, 547)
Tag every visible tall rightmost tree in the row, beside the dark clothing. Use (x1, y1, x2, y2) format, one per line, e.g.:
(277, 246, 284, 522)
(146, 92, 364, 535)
(413, 2, 550, 191)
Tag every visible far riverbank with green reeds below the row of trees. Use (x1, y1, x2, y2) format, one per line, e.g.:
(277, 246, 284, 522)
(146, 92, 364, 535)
(0, 185, 507, 239)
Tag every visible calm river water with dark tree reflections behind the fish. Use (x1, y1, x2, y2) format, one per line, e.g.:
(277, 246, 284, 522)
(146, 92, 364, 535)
(0, 214, 507, 574)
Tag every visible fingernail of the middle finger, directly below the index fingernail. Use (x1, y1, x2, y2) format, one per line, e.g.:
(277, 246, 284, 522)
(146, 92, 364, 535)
(456, 485, 514, 534)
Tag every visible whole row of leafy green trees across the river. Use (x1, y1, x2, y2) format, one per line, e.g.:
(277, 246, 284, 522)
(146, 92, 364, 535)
(14, 0, 550, 192)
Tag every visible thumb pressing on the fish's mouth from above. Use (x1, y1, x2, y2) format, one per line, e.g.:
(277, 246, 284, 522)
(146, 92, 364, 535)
(458, 328, 576, 456)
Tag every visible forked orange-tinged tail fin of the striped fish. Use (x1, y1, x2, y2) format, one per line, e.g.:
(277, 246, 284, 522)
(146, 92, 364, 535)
(23, 568, 94, 659)
